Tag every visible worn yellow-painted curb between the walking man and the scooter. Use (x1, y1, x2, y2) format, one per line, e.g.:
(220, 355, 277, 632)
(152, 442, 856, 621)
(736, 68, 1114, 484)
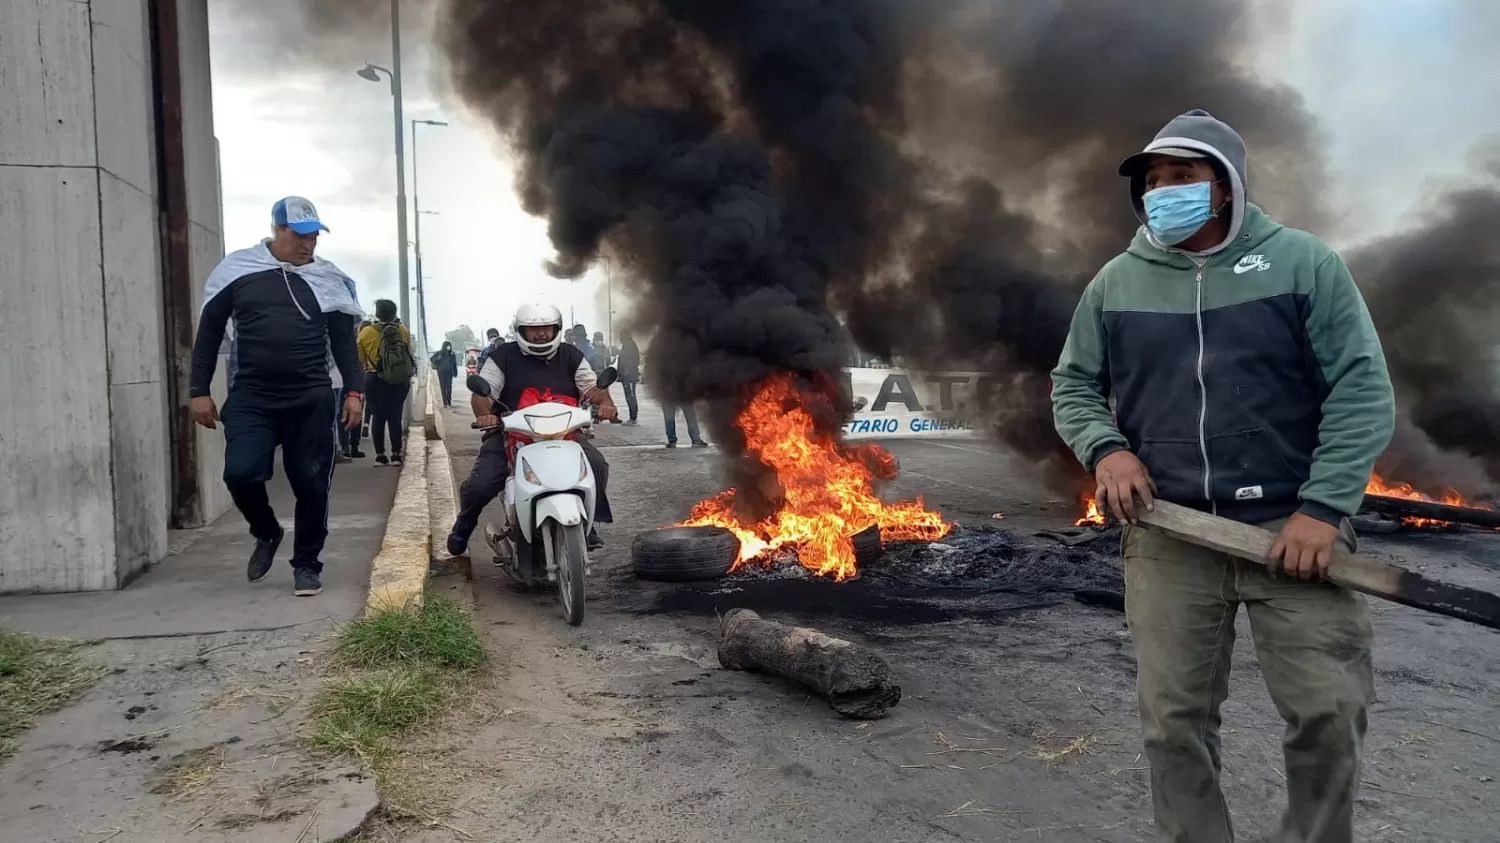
(365, 422, 432, 615)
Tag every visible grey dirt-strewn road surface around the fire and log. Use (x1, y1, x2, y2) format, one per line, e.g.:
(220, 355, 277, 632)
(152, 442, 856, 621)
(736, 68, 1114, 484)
(410, 407, 1500, 843)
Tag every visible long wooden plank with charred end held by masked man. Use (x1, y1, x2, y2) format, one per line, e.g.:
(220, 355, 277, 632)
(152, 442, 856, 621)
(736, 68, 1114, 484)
(1136, 501, 1500, 630)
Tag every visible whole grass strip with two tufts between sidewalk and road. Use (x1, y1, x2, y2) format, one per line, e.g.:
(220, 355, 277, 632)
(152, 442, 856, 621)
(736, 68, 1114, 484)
(308, 599, 485, 782)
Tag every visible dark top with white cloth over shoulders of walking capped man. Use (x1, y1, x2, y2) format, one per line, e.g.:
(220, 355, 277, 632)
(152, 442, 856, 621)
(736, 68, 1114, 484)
(189, 240, 363, 402)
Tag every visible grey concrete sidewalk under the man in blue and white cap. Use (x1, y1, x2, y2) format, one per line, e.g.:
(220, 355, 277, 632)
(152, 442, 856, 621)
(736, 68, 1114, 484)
(0, 459, 401, 843)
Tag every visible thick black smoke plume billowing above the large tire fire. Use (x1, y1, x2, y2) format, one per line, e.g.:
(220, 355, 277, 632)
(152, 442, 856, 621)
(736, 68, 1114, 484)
(438, 0, 1494, 495)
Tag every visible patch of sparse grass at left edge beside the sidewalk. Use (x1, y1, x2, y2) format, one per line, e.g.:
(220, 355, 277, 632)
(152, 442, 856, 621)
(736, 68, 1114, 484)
(0, 630, 108, 759)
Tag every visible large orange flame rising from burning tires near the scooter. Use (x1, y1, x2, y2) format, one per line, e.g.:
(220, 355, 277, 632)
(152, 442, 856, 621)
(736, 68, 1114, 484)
(683, 375, 953, 582)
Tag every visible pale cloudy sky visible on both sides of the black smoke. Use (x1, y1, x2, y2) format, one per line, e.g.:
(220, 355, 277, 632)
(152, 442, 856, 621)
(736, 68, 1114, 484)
(210, 0, 1500, 349)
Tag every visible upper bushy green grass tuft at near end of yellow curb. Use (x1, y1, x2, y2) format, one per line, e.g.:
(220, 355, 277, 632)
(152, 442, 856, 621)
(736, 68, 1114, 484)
(333, 599, 485, 669)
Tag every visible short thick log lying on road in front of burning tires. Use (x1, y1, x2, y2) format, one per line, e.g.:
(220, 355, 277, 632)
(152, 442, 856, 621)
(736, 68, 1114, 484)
(719, 609, 902, 720)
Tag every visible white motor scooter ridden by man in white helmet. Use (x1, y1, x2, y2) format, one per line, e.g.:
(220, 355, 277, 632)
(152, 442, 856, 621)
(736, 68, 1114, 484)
(465, 368, 618, 627)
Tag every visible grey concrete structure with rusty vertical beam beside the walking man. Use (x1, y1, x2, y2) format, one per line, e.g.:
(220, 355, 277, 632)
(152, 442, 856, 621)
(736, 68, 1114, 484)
(0, 0, 228, 593)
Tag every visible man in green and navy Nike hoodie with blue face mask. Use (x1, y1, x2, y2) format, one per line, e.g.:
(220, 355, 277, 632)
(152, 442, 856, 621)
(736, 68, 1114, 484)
(1052, 111, 1395, 843)
